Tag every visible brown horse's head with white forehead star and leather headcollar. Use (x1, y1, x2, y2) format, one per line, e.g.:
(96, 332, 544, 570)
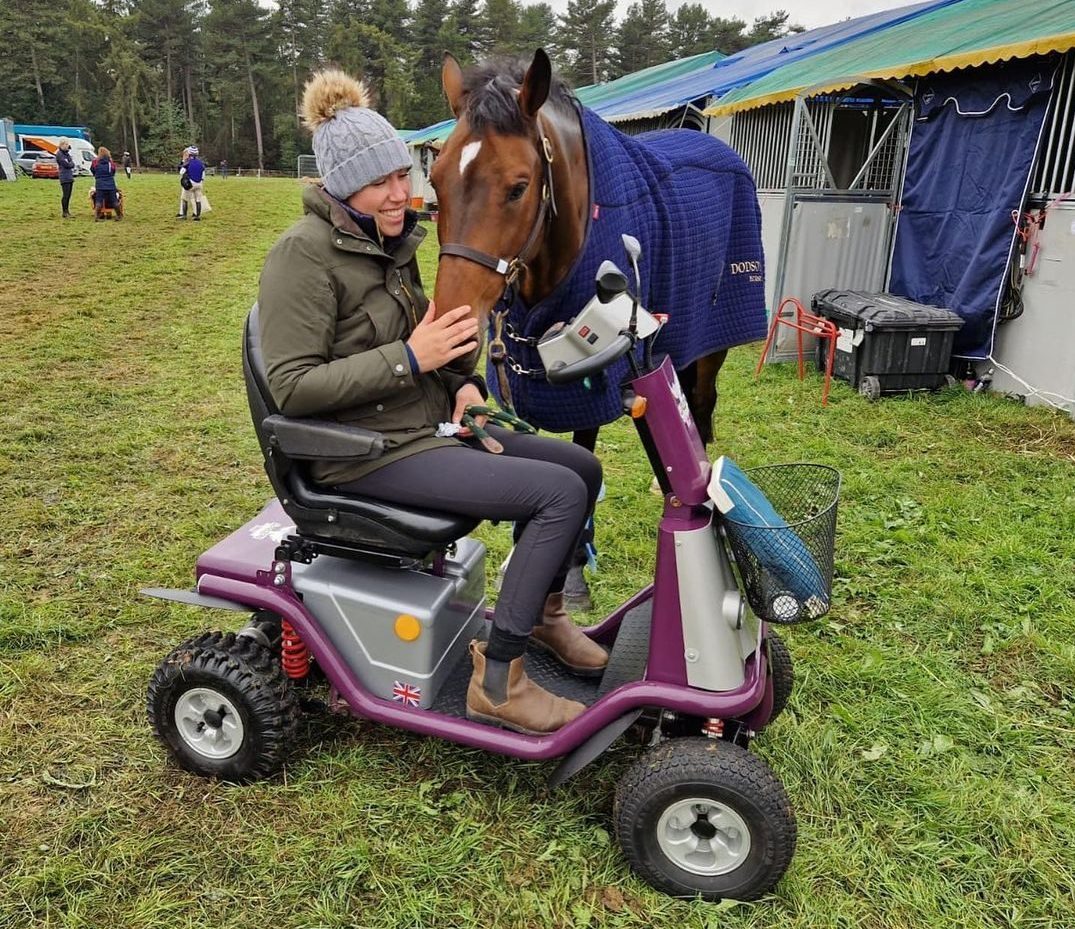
(430, 49, 585, 319)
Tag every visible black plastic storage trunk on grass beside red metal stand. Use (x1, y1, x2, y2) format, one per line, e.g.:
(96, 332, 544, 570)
(813, 289, 963, 399)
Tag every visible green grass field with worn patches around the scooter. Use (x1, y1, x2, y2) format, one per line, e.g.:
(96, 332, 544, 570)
(0, 176, 1075, 929)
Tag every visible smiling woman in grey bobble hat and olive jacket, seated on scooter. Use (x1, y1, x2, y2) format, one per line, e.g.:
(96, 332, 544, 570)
(258, 71, 607, 733)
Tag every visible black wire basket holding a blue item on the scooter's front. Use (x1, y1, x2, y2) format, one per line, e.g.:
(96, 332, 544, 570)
(720, 463, 840, 624)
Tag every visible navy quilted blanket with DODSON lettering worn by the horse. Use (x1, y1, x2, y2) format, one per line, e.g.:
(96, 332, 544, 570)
(488, 108, 766, 432)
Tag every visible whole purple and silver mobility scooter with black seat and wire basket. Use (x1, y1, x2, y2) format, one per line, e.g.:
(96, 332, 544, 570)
(143, 237, 840, 900)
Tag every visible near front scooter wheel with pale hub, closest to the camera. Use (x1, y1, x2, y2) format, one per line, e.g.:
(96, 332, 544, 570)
(614, 739, 797, 900)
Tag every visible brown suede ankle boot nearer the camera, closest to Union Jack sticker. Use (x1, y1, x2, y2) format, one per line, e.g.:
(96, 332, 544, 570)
(467, 641, 586, 735)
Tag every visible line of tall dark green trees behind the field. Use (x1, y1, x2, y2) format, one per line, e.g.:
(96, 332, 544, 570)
(0, 0, 801, 170)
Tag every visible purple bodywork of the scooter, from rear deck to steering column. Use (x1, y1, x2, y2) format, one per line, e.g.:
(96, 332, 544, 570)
(189, 359, 773, 760)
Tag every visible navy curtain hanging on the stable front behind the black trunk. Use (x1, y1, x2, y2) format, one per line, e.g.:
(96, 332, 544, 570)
(889, 56, 1058, 358)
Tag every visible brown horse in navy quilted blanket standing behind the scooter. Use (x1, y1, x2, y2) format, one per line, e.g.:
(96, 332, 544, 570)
(430, 49, 766, 602)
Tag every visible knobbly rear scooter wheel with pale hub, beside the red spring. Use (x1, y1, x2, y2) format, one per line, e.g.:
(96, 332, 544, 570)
(147, 632, 299, 783)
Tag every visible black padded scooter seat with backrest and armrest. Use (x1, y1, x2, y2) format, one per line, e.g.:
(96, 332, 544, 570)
(243, 303, 481, 558)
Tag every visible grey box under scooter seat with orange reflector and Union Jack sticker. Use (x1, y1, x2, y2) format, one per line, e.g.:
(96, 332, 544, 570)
(291, 538, 485, 708)
